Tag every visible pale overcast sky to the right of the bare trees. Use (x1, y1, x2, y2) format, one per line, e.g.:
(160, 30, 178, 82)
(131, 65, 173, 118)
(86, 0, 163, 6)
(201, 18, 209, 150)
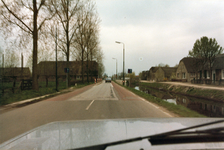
(95, 0, 224, 76)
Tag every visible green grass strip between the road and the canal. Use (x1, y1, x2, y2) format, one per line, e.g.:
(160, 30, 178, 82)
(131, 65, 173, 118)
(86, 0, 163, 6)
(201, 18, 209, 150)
(115, 81, 206, 117)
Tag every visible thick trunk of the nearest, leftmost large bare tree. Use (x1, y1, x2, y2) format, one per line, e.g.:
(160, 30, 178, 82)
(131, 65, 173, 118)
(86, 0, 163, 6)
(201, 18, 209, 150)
(32, 0, 38, 90)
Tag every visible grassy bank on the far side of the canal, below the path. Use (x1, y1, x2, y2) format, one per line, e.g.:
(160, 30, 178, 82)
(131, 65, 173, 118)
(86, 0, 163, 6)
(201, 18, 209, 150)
(140, 82, 224, 102)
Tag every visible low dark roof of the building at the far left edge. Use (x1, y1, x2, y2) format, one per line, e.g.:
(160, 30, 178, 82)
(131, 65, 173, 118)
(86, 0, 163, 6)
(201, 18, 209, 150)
(0, 67, 31, 77)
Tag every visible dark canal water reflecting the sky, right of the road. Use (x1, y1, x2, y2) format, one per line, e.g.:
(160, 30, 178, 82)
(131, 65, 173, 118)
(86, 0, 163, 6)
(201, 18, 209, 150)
(135, 86, 224, 117)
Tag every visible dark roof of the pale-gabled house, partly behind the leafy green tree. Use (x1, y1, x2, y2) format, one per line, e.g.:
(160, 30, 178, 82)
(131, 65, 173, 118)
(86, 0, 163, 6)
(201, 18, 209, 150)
(180, 57, 197, 73)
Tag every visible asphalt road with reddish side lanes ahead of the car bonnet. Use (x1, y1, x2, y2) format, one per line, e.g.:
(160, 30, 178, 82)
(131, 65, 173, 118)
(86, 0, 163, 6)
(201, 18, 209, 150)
(0, 82, 172, 143)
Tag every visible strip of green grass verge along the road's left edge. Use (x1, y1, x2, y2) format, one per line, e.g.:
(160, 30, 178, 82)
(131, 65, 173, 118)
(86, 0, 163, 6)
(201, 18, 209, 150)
(0, 82, 92, 106)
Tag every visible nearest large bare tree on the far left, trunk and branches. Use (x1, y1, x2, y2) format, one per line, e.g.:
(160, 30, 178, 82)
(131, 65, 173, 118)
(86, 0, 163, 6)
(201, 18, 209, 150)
(0, 0, 53, 90)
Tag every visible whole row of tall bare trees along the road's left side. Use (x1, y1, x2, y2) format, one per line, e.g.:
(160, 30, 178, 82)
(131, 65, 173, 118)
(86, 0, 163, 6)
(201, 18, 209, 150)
(0, 0, 104, 90)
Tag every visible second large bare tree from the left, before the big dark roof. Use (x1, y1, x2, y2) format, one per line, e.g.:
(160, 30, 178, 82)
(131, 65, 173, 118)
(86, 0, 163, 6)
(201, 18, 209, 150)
(49, 0, 82, 87)
